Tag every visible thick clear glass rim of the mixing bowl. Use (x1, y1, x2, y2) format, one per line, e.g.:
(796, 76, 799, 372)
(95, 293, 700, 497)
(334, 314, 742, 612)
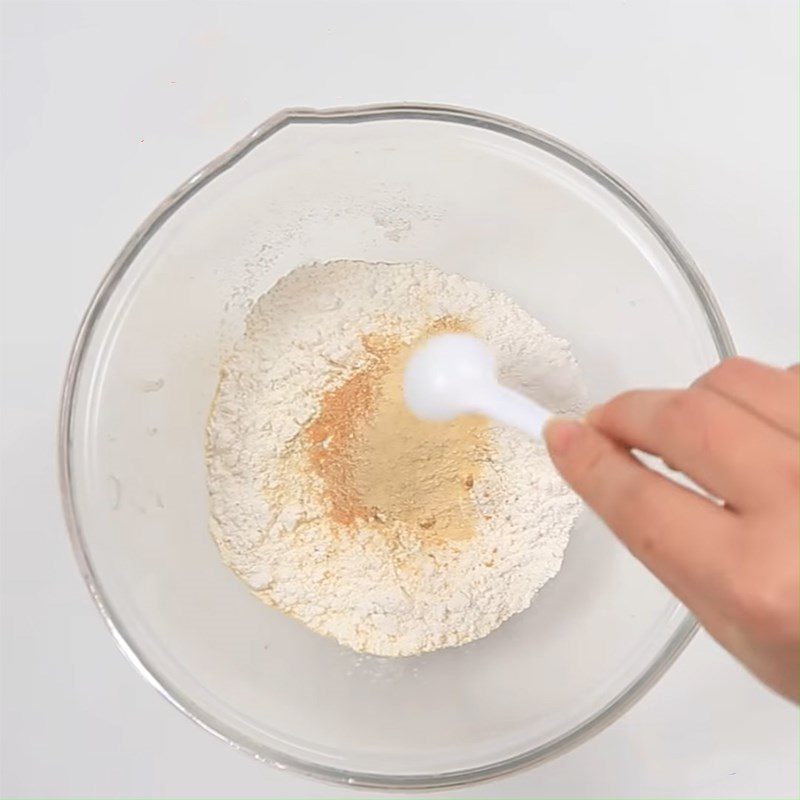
(58, 103, 735, 791)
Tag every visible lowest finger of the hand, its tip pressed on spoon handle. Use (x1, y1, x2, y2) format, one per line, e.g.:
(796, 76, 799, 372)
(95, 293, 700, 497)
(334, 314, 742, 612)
(545, 419, 733, 592)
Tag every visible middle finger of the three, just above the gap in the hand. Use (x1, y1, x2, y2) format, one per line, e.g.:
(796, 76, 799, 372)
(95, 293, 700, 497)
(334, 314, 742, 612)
(587, 387, 797, 509)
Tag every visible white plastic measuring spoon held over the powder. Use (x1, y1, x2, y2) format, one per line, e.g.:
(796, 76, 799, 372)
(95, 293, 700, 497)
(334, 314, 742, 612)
(403, 333, 550, 439)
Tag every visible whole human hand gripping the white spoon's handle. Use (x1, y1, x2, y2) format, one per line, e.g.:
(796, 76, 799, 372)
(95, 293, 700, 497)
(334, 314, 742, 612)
(545, 358, 800, 701)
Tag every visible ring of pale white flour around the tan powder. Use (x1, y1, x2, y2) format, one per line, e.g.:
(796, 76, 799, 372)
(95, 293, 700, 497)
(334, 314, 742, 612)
(207, 261, 584, 656)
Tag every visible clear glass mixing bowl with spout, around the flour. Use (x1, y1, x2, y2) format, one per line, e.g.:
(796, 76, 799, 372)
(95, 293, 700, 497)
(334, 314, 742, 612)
(60, 105, 733, 788)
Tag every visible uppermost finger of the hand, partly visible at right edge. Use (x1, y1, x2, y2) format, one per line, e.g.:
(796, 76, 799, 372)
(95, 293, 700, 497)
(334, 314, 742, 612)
(695, 358, 800, 436)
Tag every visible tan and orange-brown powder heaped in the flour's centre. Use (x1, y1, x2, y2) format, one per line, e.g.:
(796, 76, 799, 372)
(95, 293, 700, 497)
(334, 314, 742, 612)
(305, 317, 486, 541)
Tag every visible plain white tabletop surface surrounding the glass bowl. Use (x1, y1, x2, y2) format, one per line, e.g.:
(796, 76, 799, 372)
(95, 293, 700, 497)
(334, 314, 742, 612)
(0, 0, 799, 798)
